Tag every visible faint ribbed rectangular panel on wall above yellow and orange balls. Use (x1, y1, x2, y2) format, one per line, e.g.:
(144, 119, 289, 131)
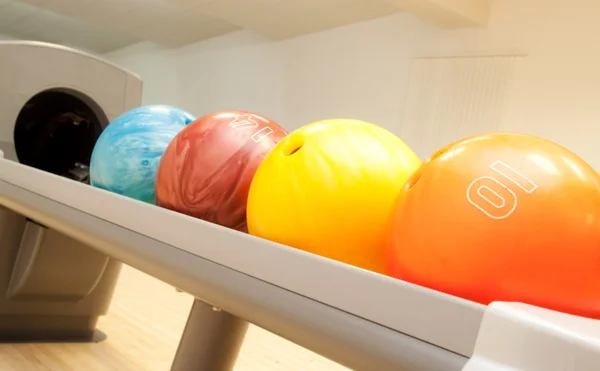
(400, 55, 523, 159)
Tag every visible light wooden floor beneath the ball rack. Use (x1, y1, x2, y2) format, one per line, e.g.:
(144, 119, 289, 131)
(0, 267, 348, 371)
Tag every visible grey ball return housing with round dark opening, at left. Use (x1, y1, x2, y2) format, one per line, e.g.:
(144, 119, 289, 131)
(0, 41, 142, 341)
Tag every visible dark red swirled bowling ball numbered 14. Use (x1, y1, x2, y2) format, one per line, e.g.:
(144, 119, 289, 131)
(156, 111, 287, 232)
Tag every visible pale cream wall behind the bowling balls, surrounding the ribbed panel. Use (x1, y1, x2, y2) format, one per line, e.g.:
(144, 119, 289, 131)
(104, 0, 600, 168)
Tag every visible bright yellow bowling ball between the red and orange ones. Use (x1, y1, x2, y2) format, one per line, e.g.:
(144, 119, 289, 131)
(248, 119, 421, 272)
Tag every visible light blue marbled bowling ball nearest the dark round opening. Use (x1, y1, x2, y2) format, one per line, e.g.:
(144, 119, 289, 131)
(90, 105, 195, 204)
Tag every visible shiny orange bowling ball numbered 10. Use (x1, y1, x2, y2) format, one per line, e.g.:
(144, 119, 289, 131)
(387, 133, 600, 318)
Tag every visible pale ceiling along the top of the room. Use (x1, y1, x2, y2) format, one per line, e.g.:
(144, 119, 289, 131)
(0, 0, 489, 53)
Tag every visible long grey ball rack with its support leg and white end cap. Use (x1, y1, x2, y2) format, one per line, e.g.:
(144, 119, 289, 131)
(0, 152, 600, 371)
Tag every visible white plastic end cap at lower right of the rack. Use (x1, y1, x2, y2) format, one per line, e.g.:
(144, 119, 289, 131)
(463, 303, 600, 371)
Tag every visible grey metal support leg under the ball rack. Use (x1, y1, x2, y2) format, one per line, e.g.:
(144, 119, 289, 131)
(171, 299, 248, 371)
